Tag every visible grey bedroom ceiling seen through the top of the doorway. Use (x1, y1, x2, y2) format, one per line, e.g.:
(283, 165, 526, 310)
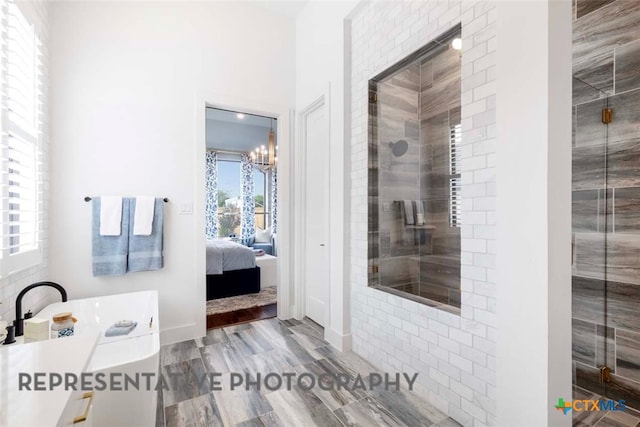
(206, 108, 278, 153)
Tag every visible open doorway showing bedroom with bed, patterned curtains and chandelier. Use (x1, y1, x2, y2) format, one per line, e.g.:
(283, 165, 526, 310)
(204, 107, 278, 329)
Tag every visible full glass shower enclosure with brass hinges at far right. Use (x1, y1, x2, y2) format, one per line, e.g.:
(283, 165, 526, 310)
(572, 80, 640, 409)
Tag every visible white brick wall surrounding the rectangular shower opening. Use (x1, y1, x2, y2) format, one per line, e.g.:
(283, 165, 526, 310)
(350, 0, 496, 426)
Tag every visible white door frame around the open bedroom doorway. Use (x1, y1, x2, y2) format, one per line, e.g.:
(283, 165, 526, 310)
(194, 92, 300, 336)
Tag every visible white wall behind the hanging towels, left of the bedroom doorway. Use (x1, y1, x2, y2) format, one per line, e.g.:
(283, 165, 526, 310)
(49, 1, 295, 342)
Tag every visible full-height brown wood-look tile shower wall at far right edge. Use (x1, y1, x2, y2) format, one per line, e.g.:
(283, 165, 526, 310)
(572, 0, 640, 414)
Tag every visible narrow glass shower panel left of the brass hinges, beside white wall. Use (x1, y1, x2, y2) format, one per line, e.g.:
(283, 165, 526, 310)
(572, 88, 613, 399)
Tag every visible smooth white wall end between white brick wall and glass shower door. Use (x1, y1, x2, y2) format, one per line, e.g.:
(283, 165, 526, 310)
(496, 0, 572, 426)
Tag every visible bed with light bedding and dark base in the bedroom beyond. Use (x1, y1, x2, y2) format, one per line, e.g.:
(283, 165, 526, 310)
(207, 239, 260, 301)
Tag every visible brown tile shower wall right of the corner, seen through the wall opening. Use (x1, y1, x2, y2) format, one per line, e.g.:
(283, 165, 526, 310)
(417, 41, 461, 307)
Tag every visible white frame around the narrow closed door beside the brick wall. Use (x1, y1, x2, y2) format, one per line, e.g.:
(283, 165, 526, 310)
(294, 85, 332, 324)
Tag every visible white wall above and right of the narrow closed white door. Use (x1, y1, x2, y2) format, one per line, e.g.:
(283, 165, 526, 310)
(296, 1, 357, 350)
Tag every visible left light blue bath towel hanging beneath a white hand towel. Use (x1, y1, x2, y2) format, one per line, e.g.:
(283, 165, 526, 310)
(91, 197, 129, 276)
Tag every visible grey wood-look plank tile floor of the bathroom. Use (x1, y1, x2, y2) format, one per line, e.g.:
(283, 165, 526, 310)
(156, 318, 460, 427)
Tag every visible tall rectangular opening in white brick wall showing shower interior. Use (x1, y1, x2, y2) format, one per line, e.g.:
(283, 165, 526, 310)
(368, 25, 463, 313)
